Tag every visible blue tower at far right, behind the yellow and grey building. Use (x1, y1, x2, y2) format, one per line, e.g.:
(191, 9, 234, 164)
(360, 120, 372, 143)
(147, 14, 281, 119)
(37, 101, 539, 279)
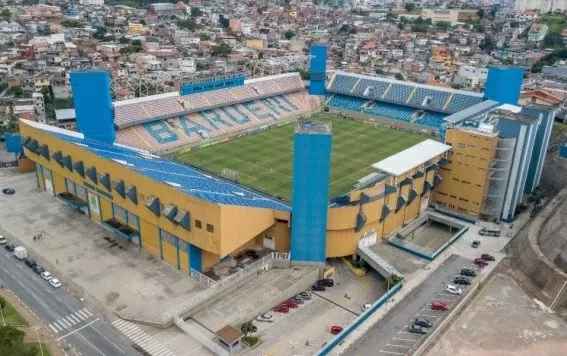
(484, 67, 524, 105)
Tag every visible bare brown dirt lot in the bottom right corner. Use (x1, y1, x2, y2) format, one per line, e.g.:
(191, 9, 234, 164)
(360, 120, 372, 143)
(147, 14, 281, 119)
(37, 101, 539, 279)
(426, 274, 567, 356)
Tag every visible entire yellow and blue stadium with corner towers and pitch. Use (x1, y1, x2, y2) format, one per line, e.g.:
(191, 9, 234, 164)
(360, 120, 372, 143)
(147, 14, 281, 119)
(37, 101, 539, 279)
(16, 46, 554, 274)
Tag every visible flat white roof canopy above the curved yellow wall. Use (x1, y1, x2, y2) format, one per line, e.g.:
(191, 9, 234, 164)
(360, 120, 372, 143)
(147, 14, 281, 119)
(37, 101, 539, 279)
(372, 140, 451, 176)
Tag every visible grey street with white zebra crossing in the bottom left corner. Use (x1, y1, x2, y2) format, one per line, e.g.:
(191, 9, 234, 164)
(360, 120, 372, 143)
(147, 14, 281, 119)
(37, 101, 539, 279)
(0, 245, 139, 356)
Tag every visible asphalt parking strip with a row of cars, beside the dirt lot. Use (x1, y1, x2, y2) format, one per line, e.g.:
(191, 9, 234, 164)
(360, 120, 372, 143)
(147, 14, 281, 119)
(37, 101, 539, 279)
(344, 255, 473, 356)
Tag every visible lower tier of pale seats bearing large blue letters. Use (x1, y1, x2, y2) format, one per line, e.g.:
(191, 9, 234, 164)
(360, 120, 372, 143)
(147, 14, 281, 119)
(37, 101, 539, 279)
(116, 91, 312, 152)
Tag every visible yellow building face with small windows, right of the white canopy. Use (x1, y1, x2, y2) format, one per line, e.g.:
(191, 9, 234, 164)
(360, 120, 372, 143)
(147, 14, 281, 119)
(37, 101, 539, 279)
(431, 129, 499, 219)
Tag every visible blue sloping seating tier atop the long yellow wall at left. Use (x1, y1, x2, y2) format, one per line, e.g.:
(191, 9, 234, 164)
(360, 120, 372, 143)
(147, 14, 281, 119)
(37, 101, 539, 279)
(22, 120, 291, 211)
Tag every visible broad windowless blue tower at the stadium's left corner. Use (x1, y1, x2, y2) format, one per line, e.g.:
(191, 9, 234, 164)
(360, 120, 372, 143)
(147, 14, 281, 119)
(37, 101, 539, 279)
(71, 71, 116, 143)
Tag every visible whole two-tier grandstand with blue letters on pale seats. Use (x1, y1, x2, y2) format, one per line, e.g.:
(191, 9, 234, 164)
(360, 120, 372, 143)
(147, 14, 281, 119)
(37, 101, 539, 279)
(114, 73, 320, 153)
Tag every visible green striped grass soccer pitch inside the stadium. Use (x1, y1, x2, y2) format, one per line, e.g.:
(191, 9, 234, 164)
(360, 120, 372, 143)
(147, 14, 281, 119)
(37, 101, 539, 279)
(171, 114, 427, 200)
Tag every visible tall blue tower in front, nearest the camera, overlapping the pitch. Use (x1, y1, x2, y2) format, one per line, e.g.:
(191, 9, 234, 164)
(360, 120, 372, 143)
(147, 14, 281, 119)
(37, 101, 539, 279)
(291, 121, 332, 264)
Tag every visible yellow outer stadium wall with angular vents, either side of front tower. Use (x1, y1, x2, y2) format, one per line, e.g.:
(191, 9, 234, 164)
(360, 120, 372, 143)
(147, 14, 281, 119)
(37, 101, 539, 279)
(20, 123, 441, 273)
